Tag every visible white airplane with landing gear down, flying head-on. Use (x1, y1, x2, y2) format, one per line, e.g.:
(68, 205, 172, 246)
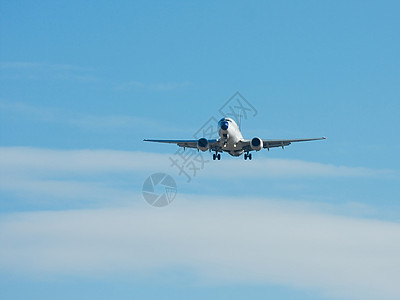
(144, 118, 326, 160)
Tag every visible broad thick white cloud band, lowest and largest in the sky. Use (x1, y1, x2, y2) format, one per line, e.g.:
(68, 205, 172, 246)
(0, 197, 400, 299)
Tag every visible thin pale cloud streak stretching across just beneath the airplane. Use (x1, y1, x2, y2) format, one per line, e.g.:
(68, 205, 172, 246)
(0, 147, 396, 177)
